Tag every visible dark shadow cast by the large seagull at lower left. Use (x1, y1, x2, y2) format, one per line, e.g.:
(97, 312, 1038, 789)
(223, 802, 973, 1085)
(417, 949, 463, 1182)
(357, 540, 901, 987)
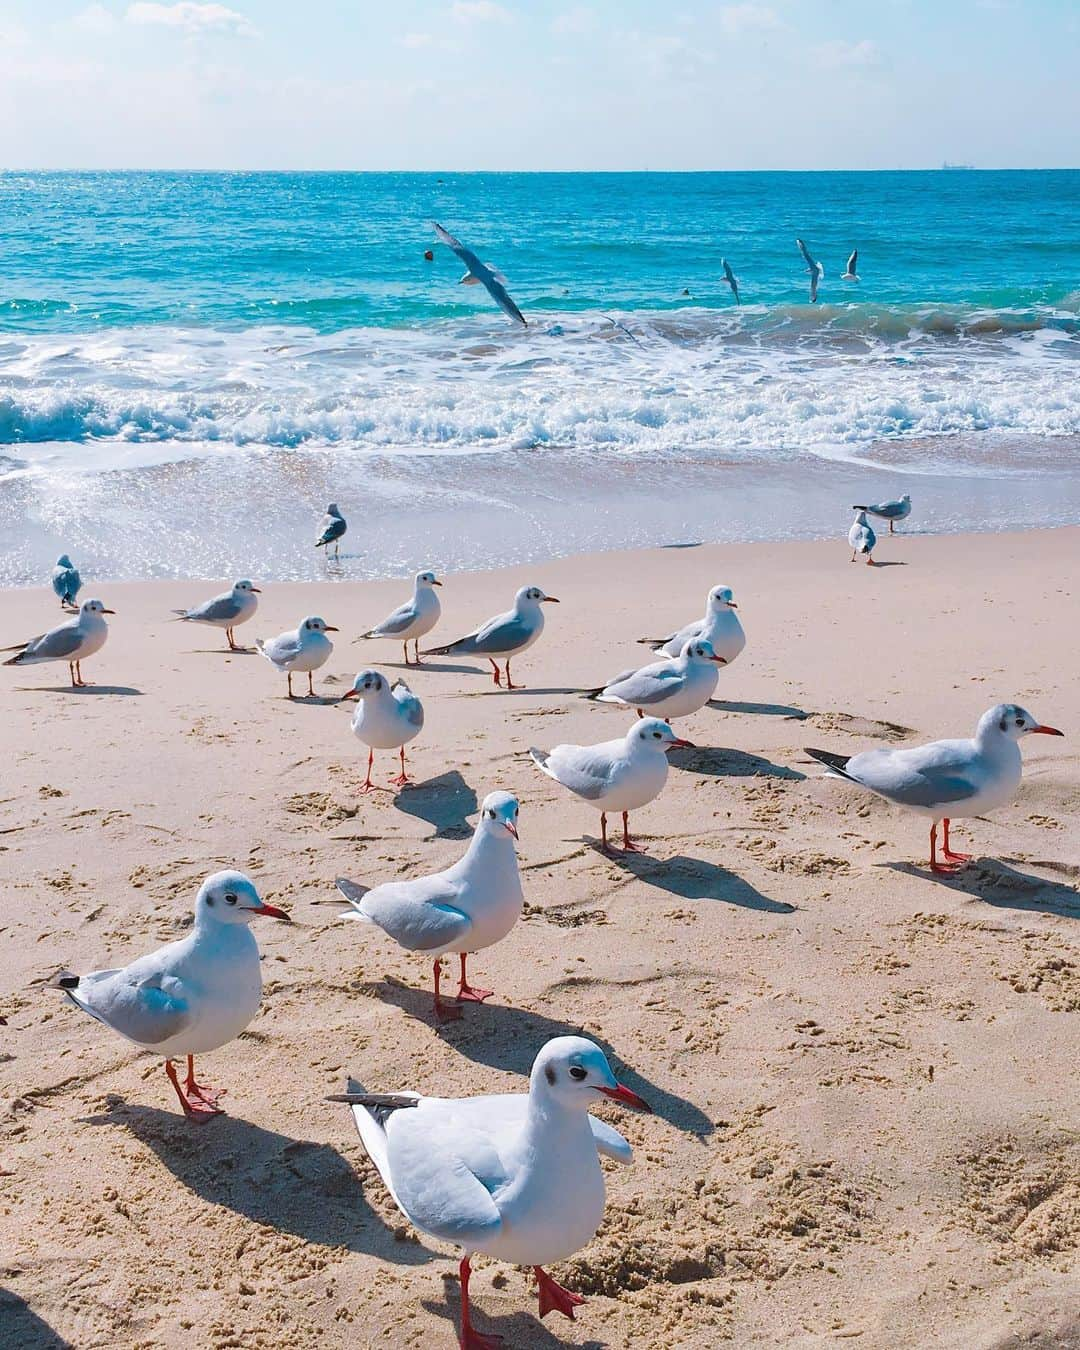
(81, 1098, 431, 1264)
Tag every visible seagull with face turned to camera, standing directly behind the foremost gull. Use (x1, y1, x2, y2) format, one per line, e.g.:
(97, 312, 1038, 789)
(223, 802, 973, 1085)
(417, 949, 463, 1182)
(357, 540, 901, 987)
(338, 792, 522, 1021)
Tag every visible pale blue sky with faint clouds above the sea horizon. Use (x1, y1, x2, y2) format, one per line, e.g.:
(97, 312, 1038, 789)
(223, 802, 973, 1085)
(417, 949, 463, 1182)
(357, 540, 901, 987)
(0, 0, 1080, 170)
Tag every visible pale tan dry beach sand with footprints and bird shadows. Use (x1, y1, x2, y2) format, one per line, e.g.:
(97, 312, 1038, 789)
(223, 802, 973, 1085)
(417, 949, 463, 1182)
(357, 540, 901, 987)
(0, 529, 1080, 1350)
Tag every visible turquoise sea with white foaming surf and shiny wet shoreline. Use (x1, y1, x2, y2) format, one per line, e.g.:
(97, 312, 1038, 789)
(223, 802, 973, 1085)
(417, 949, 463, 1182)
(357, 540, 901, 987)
(0, 170, 1080, 585)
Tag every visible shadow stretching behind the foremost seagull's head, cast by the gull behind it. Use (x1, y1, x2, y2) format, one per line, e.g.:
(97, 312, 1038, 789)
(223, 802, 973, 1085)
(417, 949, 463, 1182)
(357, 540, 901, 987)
(367, 972, 714, 1135)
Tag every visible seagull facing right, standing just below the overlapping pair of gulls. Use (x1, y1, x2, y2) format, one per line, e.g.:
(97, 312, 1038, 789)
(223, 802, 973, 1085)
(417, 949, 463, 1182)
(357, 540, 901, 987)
(529, 717, 694, 853)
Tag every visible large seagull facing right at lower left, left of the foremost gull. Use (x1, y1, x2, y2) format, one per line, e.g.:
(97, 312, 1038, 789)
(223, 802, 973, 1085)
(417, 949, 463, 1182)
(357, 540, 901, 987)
(51, 872, 289, 1121)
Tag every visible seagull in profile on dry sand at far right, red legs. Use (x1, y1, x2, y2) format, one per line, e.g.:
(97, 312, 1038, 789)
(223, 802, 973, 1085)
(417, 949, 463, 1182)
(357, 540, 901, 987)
(806, 703, 1065, 872)
